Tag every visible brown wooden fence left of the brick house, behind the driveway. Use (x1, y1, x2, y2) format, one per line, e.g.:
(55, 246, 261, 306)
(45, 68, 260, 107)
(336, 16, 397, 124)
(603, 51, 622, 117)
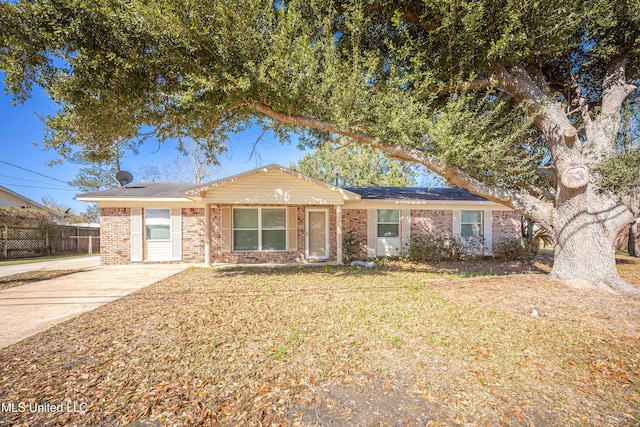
(0, 223, 100, 259)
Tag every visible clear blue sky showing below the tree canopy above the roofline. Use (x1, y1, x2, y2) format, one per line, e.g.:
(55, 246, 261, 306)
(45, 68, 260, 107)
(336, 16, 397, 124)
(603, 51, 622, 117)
(0, 73, 305, 213)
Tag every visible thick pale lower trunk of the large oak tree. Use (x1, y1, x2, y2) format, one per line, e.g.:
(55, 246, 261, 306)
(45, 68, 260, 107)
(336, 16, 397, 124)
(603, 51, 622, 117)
(551, 189, 640, 294)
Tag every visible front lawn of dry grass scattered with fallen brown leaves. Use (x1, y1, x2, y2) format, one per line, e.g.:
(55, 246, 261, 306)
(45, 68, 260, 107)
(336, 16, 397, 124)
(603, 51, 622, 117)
(0, 258, 640, 426)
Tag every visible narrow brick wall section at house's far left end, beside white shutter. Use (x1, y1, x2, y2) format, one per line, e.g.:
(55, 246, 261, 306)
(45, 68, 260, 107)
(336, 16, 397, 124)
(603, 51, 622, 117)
(100, 208, 131, 265)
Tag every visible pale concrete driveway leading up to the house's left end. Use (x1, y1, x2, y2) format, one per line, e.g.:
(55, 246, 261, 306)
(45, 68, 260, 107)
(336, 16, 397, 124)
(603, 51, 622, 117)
(0, 264, 189, 348)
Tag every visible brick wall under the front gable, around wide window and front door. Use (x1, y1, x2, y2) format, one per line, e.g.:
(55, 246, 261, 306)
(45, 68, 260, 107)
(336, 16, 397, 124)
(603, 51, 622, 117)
(211, 205, 344, 264)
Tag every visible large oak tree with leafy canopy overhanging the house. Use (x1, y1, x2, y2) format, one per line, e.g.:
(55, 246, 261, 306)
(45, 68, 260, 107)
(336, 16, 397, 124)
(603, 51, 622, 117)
(0, 0, 640, 292)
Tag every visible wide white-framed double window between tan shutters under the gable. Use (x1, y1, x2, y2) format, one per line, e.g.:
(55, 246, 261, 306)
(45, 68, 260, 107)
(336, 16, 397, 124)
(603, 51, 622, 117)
(233, 208, 287, 252)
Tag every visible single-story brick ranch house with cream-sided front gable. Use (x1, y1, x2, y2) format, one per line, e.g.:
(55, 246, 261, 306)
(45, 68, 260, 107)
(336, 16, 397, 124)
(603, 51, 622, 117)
(78, 165, 520, 265)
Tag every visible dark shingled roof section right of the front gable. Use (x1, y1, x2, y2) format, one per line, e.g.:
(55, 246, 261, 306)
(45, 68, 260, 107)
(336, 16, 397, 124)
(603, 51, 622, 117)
(345, 187, 487, 202)
